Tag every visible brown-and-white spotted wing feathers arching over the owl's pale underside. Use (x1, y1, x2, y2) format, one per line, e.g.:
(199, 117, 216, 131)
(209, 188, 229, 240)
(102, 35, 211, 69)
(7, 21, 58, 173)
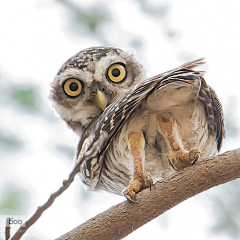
(76, 59, 225, 188)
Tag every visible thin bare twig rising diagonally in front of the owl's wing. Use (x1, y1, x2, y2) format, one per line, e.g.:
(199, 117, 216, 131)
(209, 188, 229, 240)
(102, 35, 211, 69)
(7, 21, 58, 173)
(8, 133, 107, 240)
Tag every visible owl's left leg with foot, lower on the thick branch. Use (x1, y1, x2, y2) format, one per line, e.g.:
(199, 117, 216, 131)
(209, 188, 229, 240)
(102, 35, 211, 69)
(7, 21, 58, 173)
(123, 132, 153, 201)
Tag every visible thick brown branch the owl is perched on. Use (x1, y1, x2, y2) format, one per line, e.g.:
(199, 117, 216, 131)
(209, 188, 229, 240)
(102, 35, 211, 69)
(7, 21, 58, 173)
(57, 148, 240, 240)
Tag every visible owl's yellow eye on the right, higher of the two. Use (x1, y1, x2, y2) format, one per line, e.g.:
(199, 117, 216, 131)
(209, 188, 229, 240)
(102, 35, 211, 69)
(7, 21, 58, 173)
(107, 63, 127, 83)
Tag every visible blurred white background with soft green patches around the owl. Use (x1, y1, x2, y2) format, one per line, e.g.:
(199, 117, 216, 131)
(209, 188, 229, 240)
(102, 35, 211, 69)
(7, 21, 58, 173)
(0, 0, 240, 240)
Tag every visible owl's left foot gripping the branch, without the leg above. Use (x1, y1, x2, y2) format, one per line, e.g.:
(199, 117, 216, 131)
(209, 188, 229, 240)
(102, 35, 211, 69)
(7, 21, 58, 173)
(123, 173, 153, 202)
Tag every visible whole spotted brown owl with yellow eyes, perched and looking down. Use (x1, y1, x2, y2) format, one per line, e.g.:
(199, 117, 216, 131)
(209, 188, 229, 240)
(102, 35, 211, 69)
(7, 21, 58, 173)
(50, 47, 225, 201)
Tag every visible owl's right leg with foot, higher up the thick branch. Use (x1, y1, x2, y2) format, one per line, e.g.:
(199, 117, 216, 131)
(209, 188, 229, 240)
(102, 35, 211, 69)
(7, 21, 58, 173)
(157, 113, 201, 170)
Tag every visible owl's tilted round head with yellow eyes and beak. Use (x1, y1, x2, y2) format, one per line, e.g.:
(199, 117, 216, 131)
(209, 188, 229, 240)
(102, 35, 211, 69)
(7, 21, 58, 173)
(50, 47, 145, 135)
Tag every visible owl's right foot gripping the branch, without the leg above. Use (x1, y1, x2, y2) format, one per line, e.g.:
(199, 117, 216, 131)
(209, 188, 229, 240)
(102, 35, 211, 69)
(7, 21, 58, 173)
(167, 148, 201, 171)
